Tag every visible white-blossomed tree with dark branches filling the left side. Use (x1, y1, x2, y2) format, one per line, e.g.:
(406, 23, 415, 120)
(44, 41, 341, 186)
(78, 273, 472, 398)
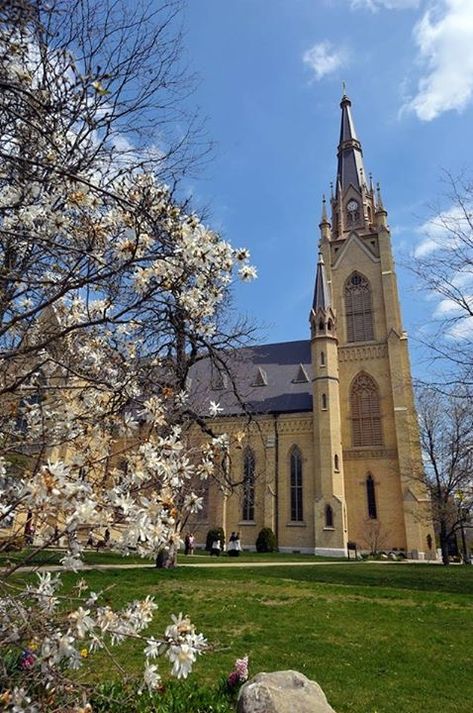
(0, 0, 256, 711)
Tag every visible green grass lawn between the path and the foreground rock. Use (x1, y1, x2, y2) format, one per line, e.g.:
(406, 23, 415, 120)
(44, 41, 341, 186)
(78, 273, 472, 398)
(13, 563, 473, 713)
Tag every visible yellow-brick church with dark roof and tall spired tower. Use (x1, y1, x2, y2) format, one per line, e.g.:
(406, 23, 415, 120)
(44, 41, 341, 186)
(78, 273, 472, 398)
(188, 95, 435, 559)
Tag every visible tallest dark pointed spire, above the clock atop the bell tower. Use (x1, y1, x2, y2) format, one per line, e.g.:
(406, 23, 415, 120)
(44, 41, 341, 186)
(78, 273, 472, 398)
(337, 94, 365, 193)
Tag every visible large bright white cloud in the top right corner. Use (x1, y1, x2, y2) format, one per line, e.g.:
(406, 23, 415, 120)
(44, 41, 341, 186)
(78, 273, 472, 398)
(403, 0, 473, 121)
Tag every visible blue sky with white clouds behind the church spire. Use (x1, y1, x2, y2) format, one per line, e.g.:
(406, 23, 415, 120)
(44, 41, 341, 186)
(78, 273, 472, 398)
(178, 0, 473, 374)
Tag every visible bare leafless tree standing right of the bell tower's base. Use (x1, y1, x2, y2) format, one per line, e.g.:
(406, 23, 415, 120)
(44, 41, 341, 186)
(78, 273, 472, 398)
(417, 387, 473, 565)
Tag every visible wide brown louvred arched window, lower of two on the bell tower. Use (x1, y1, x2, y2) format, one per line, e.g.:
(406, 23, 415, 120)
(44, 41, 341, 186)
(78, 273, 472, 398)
(350, 373, 383, 447)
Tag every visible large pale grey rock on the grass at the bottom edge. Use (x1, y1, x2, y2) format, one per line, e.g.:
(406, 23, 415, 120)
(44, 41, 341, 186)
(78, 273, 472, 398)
(237, 671, 335, 713)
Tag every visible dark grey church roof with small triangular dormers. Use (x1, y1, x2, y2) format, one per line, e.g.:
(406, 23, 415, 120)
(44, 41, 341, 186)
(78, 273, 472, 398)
(189, 339, 312, 416)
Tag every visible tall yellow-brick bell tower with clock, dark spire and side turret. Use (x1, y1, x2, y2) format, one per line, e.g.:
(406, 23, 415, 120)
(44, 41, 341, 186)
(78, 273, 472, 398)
(310, 94, 434, 558)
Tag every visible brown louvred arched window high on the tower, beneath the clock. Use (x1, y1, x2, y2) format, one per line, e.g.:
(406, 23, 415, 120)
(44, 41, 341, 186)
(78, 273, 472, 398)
(345, 272, 374, 342)
